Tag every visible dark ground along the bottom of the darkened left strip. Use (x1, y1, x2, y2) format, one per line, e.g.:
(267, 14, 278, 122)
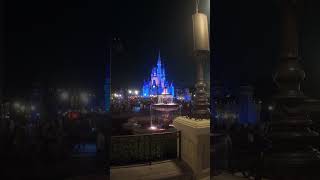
(0, 144, 108, 180)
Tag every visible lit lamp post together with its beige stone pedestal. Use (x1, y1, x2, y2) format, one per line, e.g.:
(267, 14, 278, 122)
(173, 1, 210, 180)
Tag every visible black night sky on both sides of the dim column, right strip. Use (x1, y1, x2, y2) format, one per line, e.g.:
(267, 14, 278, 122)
(211, 0, 320, 98)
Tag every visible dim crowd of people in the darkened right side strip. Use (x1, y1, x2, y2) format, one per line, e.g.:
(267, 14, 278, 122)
(214, 123, 268, 176)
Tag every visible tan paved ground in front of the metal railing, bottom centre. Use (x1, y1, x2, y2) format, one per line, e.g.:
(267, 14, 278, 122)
(111, 161, 192, 180)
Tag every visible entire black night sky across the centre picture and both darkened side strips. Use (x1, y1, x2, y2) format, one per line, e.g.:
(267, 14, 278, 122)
(5, 0, 320, 97)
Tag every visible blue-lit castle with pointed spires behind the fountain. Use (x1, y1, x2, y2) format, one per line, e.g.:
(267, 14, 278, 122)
(142, 51, 174, 97)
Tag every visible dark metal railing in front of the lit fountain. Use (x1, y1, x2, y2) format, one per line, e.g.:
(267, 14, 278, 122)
(110, 131, 181, 166)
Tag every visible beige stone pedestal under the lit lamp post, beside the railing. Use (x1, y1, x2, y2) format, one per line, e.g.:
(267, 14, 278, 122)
(173, 116, 210, 180)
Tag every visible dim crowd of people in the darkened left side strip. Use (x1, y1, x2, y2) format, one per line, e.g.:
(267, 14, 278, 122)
(0, 112, 109, 177)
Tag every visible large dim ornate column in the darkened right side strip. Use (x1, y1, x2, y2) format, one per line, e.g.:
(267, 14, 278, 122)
(264, 0, 320, 180)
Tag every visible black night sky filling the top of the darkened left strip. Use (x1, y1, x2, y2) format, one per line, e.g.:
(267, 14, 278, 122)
(6, 0, 111, 97)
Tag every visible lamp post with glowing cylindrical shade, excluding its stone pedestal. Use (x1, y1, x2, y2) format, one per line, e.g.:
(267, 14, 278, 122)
(191, 0, 210, 119)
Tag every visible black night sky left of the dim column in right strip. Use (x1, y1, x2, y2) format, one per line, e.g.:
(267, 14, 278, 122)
(212, 0, 279, 97)
